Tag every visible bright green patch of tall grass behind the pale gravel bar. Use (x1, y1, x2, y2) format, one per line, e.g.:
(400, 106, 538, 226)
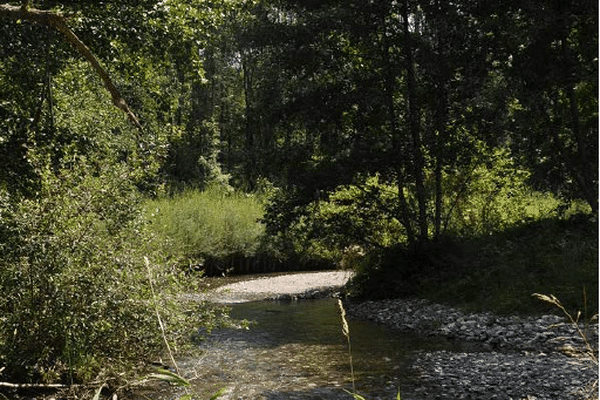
(144, 185, 264, 263)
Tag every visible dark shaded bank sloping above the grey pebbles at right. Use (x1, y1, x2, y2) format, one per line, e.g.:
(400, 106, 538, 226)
(348, 215, 598, 317)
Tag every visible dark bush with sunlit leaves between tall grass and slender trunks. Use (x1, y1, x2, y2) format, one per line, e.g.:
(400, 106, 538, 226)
(265, 176, 404, 267)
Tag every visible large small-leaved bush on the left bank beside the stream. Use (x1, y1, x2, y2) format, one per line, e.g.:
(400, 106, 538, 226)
(0, 156, 223, 381)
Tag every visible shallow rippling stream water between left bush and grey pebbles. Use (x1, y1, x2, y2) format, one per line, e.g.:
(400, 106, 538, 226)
(166, 299, 476, 400)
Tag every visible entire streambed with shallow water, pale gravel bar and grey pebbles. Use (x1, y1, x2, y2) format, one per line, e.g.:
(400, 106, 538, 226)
(152, 273, 598, 400)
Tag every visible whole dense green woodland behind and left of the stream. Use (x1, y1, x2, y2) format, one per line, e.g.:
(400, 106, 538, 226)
(0, 0, 598, 394)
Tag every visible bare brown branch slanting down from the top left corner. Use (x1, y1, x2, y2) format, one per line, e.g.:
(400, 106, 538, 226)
(0, 4, 143, 132)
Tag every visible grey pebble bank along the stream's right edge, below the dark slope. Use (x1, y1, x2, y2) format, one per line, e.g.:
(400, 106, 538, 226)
(347, 300, 598, 400)
